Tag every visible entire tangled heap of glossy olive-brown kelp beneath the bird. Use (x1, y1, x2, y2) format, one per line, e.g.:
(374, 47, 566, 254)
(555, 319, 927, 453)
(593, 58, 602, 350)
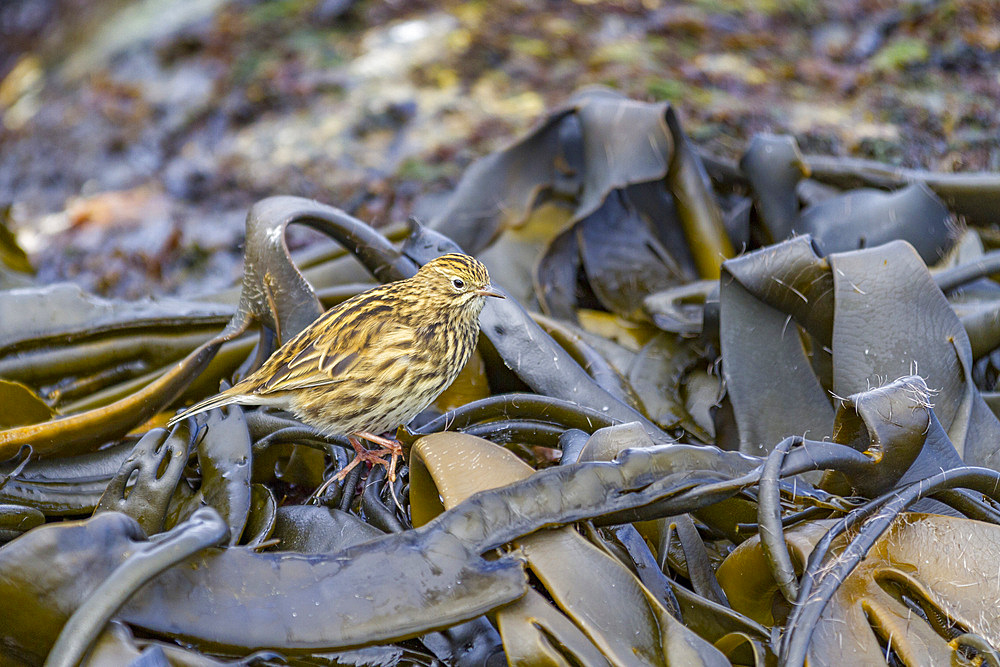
(0, 90, 1000, 665)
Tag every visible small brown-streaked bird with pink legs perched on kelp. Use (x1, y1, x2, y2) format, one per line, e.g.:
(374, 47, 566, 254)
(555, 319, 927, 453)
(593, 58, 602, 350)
(168, 254, 503, 489)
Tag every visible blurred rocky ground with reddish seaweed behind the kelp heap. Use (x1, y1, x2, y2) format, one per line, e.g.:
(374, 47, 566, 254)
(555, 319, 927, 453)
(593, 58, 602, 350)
(0, 0, 1000, 298)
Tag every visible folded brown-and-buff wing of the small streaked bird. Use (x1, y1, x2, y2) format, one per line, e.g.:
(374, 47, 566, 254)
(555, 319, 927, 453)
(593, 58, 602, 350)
(256, 313, 416, 394)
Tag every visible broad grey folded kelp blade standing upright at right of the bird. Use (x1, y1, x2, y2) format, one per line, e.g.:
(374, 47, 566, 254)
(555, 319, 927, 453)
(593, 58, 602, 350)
(720, 237, 1000, 469)
